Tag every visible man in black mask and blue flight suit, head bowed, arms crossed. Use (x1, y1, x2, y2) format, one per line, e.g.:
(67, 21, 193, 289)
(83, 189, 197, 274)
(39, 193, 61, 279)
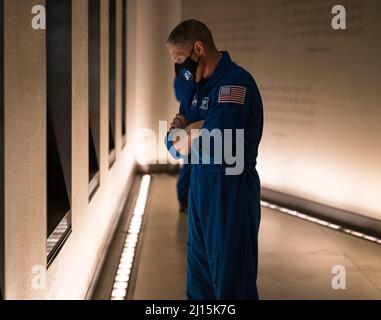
(166, 20, 263, 300)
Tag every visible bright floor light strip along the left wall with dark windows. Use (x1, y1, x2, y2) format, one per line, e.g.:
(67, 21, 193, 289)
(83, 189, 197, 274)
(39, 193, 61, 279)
(111, 175, 151, 300)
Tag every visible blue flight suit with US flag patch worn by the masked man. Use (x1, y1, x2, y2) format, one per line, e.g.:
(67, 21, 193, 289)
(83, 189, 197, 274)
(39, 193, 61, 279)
(166, 52, 263, 300)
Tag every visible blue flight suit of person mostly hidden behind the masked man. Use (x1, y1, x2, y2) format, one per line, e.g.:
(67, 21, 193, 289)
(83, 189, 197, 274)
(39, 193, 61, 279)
(174, 77, 193, 203)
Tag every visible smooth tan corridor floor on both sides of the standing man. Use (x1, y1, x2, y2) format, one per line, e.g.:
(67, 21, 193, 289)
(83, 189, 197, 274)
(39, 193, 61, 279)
(133, 174, 381, 300)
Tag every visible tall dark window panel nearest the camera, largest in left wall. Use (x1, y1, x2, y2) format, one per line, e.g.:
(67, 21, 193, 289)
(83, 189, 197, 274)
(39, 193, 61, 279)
(46, 0, 72, 264)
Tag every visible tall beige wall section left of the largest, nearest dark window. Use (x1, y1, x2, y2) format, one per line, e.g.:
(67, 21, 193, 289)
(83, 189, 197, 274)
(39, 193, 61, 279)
(4, 0, 46, 299)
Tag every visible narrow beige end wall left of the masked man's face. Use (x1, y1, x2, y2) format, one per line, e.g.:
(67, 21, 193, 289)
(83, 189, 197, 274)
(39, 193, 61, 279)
(135, 0, 181, 163)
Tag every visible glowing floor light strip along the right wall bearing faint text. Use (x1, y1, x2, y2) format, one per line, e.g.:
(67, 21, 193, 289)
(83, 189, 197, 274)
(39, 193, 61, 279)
(261, 201, 381, 244)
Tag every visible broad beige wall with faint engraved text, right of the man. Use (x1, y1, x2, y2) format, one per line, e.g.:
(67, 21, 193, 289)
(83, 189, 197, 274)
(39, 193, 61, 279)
(182, 0, 381, 220)
